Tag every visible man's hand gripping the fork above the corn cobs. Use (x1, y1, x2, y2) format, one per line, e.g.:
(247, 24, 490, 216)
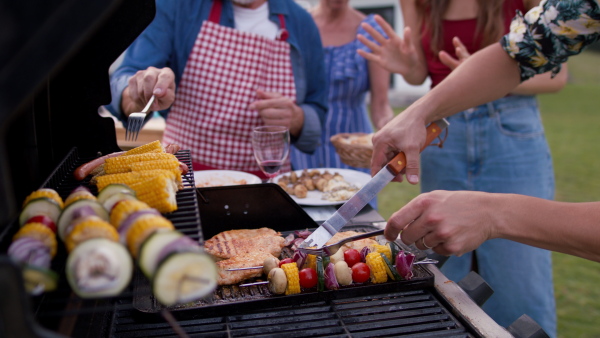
(122, 67, 175, 115)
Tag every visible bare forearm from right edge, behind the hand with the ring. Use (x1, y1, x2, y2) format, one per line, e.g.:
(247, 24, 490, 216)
(490, 194, 600, 262)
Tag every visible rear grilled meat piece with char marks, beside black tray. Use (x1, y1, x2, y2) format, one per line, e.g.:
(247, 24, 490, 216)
(204, 235, 285, 259)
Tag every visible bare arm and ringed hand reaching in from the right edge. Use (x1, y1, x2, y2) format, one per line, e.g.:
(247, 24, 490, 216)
(385, 191, 600, 262)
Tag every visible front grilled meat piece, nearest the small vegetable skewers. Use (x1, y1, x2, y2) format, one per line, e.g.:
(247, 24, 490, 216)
(217, 251, 271, 285)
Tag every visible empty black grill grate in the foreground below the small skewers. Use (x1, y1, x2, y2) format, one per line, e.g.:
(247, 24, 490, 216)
(111, 289, 473, 337)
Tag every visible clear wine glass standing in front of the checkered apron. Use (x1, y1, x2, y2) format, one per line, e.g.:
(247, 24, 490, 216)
(252, 126, 290, 182)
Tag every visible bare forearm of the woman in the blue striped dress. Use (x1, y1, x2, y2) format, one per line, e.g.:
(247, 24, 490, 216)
(368, 61, 394, 130)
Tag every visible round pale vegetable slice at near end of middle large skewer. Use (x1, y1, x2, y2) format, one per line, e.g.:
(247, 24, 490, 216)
(66, 238, 133, 298)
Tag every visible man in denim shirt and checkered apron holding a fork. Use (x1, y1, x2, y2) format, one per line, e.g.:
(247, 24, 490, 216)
(107, 0, 327, 177)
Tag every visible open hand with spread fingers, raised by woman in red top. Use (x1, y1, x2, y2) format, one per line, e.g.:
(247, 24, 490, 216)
(357, 15, 419, 75)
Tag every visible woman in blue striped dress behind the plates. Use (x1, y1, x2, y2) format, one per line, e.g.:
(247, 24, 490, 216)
(290, 0, 393, 177)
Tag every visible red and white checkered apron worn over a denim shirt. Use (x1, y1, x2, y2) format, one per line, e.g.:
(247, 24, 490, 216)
(163, 0, 296, 178)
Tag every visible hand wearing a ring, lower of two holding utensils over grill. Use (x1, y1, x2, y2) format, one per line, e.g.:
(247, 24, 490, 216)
(384, 190, 495, 256)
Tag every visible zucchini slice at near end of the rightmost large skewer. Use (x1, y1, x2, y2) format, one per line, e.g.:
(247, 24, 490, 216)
(152, 252, 217, 306)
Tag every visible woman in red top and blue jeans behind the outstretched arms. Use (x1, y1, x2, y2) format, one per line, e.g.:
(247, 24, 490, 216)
(360, 0, 567, 336)
